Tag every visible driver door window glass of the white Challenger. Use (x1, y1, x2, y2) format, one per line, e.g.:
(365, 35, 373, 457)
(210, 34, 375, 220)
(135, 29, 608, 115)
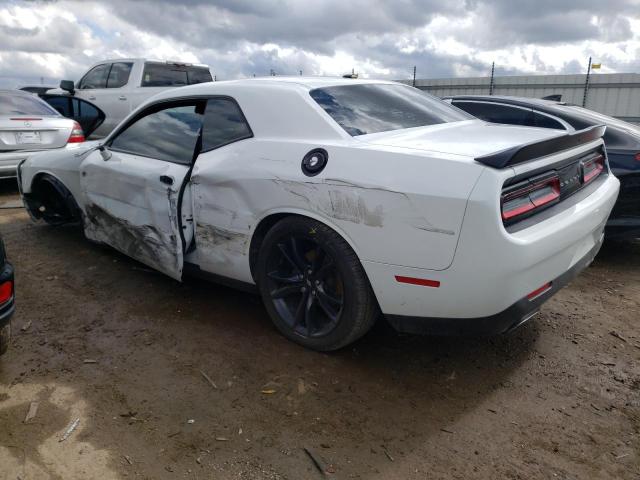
(111, 102, 202, 165)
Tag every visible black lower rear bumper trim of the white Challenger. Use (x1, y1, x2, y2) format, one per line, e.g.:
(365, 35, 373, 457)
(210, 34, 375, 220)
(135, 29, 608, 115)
(387, 235, 604, 335)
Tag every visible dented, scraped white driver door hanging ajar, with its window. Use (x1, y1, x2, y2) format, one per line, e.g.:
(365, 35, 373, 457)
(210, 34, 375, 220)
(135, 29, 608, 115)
(80, 101, 203, 280)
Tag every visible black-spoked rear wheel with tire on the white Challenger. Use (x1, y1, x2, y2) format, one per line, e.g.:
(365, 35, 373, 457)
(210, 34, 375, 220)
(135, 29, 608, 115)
(258, 217, 377, 351)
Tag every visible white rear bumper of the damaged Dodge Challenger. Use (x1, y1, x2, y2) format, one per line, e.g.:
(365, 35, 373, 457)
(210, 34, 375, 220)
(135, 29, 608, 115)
(362, 171, 619, 324)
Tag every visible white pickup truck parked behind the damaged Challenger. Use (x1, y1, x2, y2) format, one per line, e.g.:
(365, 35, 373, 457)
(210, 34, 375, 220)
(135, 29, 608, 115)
(54, 58, 212, 138)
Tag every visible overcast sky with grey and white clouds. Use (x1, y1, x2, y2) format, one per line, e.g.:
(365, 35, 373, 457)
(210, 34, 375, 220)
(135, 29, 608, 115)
(0, 0, 640, 86)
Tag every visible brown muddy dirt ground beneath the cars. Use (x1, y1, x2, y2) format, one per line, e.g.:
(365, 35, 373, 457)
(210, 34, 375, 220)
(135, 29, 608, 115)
(0, 182, 640, 480)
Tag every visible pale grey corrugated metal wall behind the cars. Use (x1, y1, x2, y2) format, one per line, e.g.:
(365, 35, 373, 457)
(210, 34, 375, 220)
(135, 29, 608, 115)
(403, 73, 640, 123)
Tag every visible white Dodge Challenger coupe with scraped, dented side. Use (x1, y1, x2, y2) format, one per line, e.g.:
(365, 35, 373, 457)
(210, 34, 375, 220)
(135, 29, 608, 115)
(18, 77, 619, 350)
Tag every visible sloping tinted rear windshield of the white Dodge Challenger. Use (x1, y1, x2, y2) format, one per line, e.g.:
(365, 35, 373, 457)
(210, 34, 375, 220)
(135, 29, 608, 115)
(309, 84, 472, 136)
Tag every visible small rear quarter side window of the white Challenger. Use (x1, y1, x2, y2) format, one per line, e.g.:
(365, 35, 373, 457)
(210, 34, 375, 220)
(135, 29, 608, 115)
(202, 98, 253, 151)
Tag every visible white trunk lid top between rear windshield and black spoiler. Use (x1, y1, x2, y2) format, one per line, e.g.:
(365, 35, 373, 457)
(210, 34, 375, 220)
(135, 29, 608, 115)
(354, 120, 567, 158)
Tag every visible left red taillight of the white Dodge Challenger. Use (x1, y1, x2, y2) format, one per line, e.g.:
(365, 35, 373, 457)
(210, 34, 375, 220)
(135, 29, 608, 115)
(500, 173, 560, 223)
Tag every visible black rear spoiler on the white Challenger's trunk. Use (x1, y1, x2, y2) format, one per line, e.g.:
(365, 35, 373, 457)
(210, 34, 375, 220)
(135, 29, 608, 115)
(475, 125, 607, 168)
